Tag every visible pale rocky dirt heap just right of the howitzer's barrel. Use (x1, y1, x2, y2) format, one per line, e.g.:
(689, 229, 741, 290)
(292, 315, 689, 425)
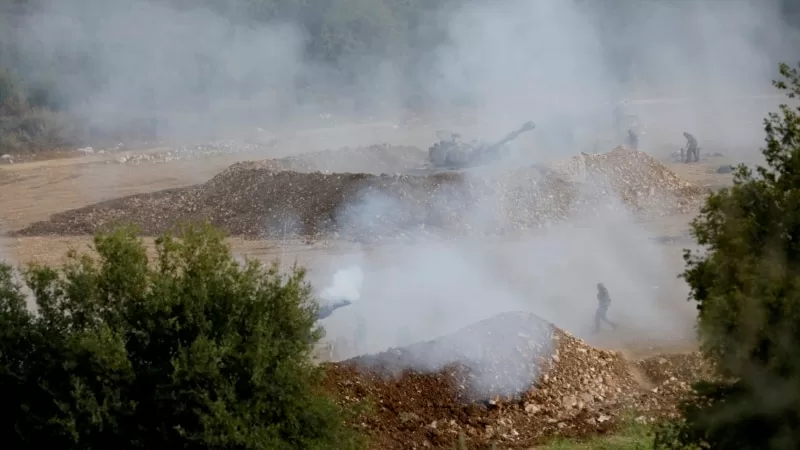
(553, 147, 708, 216)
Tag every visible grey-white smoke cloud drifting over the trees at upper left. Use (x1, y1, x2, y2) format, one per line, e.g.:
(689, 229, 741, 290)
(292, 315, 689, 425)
(14, 0, 310, 137)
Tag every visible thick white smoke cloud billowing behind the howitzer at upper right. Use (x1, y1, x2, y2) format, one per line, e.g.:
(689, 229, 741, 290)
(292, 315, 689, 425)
(434, 0, 798, 161)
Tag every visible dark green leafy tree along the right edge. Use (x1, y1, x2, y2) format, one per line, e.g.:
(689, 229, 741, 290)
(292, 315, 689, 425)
(656, 64, 800, 450)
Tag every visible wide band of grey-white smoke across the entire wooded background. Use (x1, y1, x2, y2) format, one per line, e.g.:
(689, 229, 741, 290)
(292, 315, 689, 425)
(4, 0, 798, 157)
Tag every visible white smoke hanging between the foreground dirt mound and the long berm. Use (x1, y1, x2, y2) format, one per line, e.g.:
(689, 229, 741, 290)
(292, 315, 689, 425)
(324, 171, 693, 368)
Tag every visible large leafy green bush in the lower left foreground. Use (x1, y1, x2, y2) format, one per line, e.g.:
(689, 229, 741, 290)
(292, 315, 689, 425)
(0, 225, 360, 449)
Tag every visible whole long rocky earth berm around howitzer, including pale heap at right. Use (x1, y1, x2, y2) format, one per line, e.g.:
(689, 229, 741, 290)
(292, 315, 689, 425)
(18, 146, 705, 241)
